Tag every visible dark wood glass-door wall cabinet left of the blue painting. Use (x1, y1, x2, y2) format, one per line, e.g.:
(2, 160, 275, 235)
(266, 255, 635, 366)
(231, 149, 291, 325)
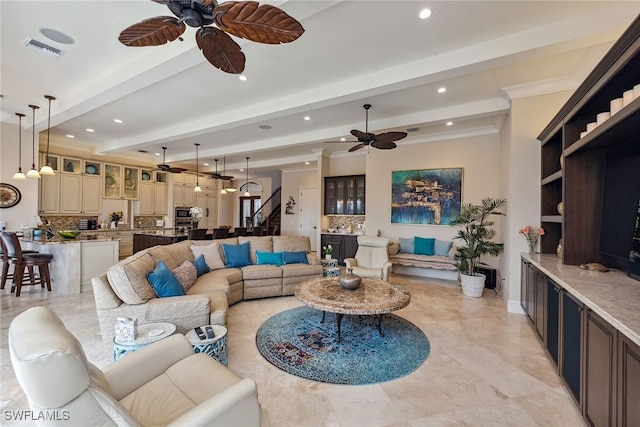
(324, 175, 365, 215)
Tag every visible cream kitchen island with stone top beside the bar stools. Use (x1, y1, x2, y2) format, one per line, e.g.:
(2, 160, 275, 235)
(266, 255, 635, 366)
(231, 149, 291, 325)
(21, 235, 119, 295)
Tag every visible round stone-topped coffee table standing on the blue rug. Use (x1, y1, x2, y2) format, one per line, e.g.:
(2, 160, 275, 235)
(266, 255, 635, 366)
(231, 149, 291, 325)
(294, 277, 411, 342)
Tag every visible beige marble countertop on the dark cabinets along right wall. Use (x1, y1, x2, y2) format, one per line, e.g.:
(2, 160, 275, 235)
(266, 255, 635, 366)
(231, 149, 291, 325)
(522, 253, 640, 345)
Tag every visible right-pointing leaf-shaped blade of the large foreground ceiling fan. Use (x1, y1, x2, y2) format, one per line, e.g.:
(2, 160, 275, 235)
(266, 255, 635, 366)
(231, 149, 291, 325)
(213, 1, 304, 44)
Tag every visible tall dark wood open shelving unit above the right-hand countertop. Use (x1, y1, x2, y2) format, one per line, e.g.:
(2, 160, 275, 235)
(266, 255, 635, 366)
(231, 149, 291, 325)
(538, 18, 640, 269)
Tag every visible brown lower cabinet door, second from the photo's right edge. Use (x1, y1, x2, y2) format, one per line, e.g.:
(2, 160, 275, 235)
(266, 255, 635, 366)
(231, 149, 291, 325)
(584, 309, 618, 427)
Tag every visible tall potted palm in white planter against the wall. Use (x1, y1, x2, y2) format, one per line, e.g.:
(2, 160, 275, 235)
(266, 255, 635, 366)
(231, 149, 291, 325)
(451, 198, 507, 297)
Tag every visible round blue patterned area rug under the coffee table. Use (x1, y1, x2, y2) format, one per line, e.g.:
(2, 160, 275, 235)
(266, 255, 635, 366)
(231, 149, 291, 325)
(256, 306, 431, 385)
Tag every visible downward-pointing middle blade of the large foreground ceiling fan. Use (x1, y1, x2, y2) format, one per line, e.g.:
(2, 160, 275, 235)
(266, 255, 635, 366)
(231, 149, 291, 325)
(196, 27, 245, 74)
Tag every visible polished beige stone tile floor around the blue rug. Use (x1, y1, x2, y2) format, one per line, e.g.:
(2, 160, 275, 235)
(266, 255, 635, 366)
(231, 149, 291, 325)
(0, 275, 585, 427)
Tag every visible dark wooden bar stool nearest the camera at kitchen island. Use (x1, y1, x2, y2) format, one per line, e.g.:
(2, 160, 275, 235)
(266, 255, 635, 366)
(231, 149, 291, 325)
(0, 232, 53, 297)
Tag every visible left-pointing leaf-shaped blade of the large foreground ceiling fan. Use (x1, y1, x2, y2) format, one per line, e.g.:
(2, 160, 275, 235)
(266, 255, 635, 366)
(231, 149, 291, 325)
(118, 16, 187, 47)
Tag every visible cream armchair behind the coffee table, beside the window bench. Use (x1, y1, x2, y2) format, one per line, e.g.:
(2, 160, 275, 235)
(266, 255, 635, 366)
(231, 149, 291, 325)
(344, 236, 391, 280)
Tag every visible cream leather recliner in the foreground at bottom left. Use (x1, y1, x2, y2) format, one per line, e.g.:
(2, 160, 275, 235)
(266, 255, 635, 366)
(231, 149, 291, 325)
(9, 307, 260, 426)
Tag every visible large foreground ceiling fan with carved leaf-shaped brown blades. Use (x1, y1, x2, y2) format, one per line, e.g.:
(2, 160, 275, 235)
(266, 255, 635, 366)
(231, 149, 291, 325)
(118, 0, 304, 74)
